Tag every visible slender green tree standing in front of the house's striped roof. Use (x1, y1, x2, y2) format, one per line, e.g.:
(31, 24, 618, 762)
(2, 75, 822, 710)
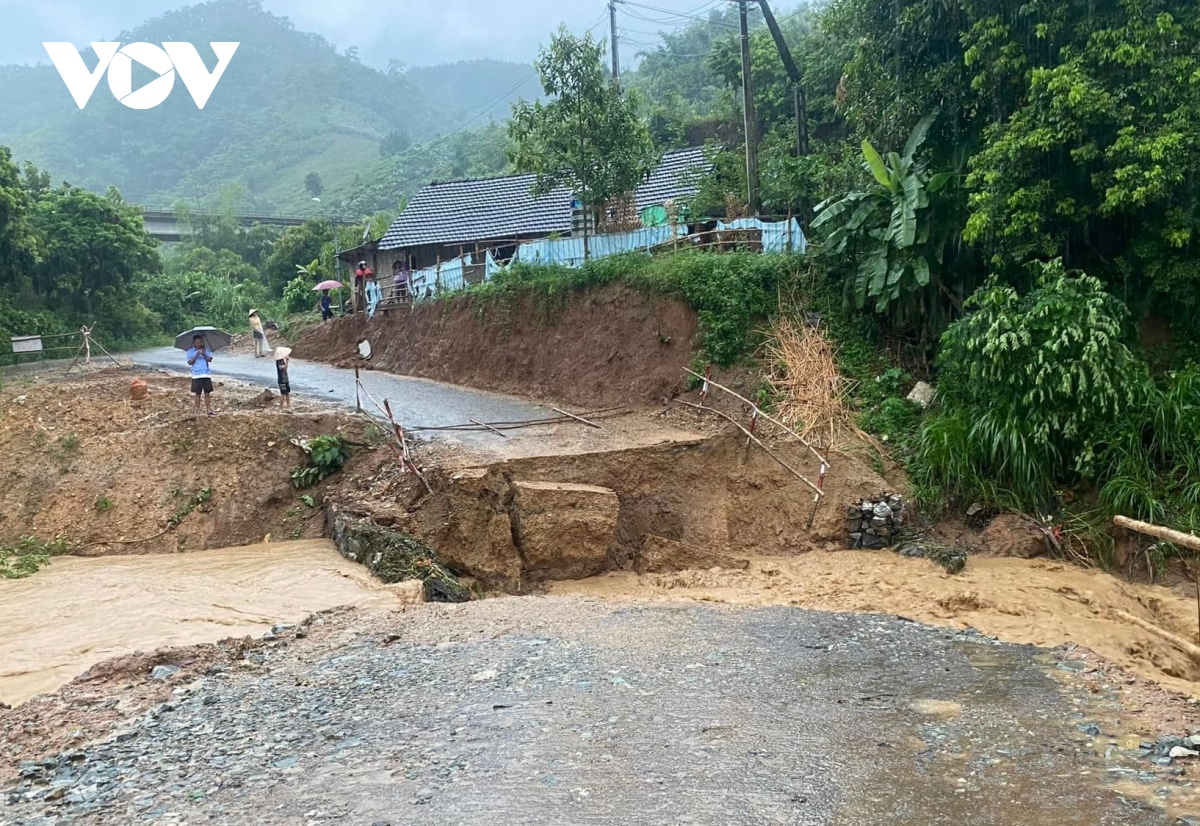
(509, 26, 656, 256)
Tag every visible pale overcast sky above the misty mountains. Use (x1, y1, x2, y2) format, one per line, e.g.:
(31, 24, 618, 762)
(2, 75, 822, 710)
(0, 0, 726, 67)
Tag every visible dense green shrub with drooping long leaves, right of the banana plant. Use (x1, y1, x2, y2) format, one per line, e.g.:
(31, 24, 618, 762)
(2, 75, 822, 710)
(922, 261, 1150, 509)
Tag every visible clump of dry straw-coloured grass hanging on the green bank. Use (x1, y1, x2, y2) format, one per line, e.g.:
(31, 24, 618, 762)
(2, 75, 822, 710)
(768, 319, 859, 447)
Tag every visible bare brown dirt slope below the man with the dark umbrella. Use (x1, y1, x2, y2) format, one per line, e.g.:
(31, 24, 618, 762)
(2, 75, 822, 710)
(0, 367, 379, 555)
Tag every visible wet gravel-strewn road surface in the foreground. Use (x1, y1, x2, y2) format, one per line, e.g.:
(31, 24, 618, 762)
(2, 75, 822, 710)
(0, 598, 1174, 826)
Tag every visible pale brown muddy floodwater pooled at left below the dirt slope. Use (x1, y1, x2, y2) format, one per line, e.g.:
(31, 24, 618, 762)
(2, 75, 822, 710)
(0, 539, 396, 704)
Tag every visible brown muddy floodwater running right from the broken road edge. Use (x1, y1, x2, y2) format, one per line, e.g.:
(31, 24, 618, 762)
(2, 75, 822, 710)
(551, 551, 1200, 695)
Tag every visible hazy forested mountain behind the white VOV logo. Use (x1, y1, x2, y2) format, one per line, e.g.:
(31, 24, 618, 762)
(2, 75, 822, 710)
(0, 0, 529, 211)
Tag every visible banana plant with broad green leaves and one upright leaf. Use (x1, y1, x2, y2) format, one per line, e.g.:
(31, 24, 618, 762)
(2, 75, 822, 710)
(812, 113, 954, 331)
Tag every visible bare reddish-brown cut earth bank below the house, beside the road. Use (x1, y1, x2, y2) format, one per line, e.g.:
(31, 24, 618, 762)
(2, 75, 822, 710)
(292, 286, 696, 407)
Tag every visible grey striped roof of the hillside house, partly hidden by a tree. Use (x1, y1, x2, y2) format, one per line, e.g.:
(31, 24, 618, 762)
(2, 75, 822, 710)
(379, 148, 709, 250)
